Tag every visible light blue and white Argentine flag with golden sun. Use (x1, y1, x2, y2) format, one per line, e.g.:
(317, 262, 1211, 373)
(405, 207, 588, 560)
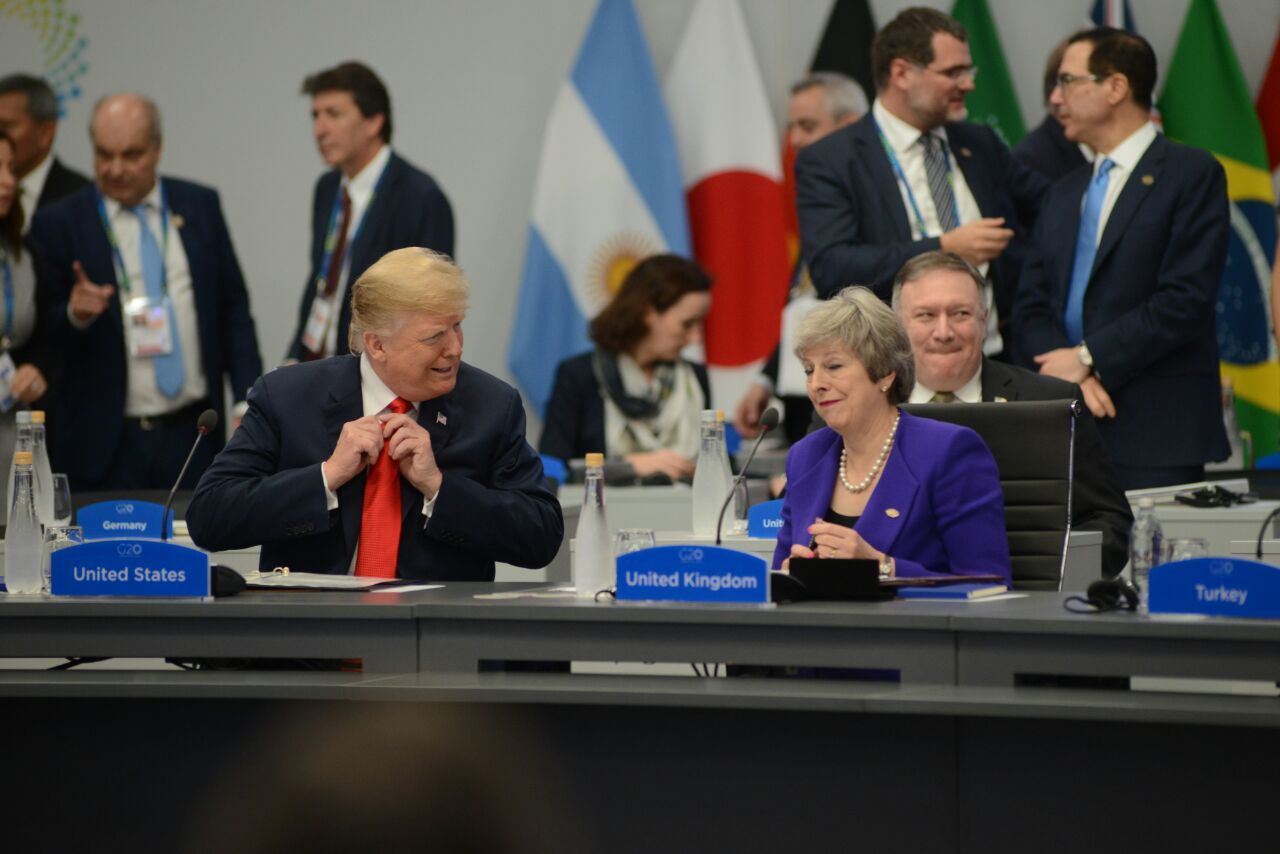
(507, 0, 689, 412)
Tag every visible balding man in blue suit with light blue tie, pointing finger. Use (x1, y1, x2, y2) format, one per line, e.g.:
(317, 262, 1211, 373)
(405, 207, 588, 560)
(31, 95, 262, 490)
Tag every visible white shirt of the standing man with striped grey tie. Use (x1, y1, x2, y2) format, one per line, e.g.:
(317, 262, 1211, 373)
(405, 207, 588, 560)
(872, 99, 1005, 356)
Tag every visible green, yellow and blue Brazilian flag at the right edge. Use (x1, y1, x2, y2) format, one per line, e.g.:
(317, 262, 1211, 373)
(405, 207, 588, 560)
(1158, 0, 1280, 457)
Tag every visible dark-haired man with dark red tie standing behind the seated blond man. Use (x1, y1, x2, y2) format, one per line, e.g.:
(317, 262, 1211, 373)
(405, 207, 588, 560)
(285, 63, 453, 361)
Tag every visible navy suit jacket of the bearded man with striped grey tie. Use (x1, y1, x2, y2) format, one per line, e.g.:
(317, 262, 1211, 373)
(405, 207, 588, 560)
(796, 113, 1048, 320)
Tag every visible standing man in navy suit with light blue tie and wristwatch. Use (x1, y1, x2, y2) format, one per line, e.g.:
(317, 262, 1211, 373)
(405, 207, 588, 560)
(1014, 28, 1230, 489)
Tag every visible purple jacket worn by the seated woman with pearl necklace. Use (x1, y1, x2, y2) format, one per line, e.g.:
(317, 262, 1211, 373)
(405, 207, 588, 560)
(773, 412, 1011, 579)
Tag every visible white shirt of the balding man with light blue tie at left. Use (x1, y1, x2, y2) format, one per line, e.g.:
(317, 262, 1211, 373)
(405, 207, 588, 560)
(99, 182, 207, 417)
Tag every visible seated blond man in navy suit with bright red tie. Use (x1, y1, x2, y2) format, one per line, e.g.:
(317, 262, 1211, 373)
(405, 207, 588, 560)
(187, 248, 564, 581)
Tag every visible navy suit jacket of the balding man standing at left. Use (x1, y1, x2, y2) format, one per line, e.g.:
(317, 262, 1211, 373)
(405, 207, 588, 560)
(29, 178, 262, 487)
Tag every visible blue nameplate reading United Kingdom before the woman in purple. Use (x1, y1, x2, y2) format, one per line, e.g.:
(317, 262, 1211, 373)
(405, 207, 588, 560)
(617, 545, 769, 603)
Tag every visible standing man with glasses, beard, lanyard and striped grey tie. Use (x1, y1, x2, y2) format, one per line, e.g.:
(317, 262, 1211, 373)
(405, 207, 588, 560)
(796, 8, 1048, 355)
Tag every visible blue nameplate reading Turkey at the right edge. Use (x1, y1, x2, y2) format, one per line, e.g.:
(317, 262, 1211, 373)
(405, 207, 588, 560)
(1147, 557, 1280, 620)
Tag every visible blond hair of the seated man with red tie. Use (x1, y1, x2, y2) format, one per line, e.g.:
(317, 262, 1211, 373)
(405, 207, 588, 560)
(347, 246, 471, 353)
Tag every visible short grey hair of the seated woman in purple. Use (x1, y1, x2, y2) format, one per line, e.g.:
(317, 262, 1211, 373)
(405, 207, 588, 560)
(795, 286, 915, 406)
